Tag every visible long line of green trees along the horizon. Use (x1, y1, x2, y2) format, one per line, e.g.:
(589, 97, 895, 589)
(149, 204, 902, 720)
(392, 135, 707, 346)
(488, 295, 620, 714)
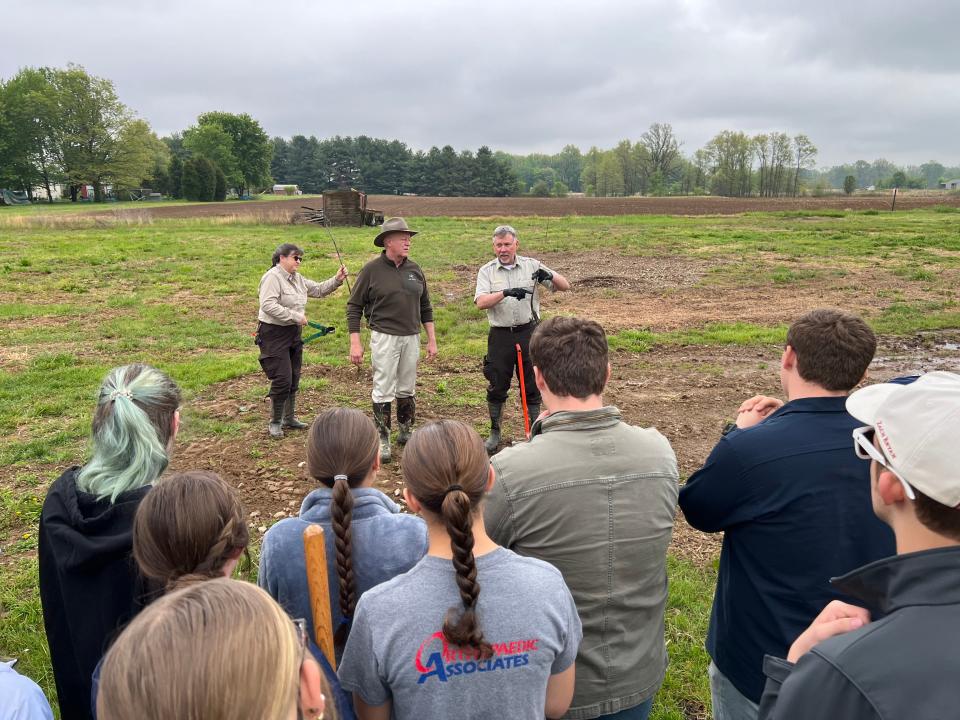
(0, 65, 960, 201)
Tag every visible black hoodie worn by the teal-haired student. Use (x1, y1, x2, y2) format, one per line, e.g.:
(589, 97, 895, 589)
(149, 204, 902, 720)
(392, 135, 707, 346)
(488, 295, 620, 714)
(38, 467, 150, 720)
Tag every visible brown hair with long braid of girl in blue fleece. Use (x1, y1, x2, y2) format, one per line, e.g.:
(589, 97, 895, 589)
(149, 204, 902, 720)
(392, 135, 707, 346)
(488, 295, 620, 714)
(307, 408, 379, 643)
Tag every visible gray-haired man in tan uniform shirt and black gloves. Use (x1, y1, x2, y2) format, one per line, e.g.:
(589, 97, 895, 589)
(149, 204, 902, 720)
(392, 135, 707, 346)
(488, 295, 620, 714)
(473, 225, 570, 455)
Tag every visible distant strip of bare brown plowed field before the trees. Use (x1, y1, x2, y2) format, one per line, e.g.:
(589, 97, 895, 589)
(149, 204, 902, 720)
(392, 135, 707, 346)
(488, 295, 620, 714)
(73, 193, 960, 221)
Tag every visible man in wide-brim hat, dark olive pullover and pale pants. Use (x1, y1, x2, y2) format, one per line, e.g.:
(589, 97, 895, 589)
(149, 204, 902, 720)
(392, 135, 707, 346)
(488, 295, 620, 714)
(347, 217, 437, 462)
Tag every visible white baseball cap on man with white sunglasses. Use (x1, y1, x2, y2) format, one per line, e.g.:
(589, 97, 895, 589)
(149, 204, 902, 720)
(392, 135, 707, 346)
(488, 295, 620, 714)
(847, 371, 960, 507)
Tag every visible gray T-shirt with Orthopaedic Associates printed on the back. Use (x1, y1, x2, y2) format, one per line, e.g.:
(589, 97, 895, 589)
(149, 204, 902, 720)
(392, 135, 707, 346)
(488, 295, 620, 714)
(338, 548, 582, 720)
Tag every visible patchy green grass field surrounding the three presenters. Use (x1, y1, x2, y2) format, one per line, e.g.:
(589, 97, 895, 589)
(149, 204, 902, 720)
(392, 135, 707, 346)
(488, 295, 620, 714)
(0, 203, 960, 720)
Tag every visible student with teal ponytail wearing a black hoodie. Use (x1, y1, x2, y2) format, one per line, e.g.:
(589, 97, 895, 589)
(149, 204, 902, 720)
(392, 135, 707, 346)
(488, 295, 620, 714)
(38, 364, 181, 720)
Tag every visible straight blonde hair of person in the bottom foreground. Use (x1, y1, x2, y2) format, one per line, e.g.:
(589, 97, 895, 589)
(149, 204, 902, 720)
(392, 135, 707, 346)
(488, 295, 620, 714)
(97, 578, 301, 720)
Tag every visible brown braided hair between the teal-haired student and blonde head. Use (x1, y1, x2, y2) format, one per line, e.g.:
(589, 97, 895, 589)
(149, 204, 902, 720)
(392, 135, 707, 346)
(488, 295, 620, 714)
(133, 470, 250, 590)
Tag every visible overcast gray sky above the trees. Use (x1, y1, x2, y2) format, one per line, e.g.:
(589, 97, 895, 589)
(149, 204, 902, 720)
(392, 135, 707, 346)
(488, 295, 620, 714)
(0, 0, 960, 167)
